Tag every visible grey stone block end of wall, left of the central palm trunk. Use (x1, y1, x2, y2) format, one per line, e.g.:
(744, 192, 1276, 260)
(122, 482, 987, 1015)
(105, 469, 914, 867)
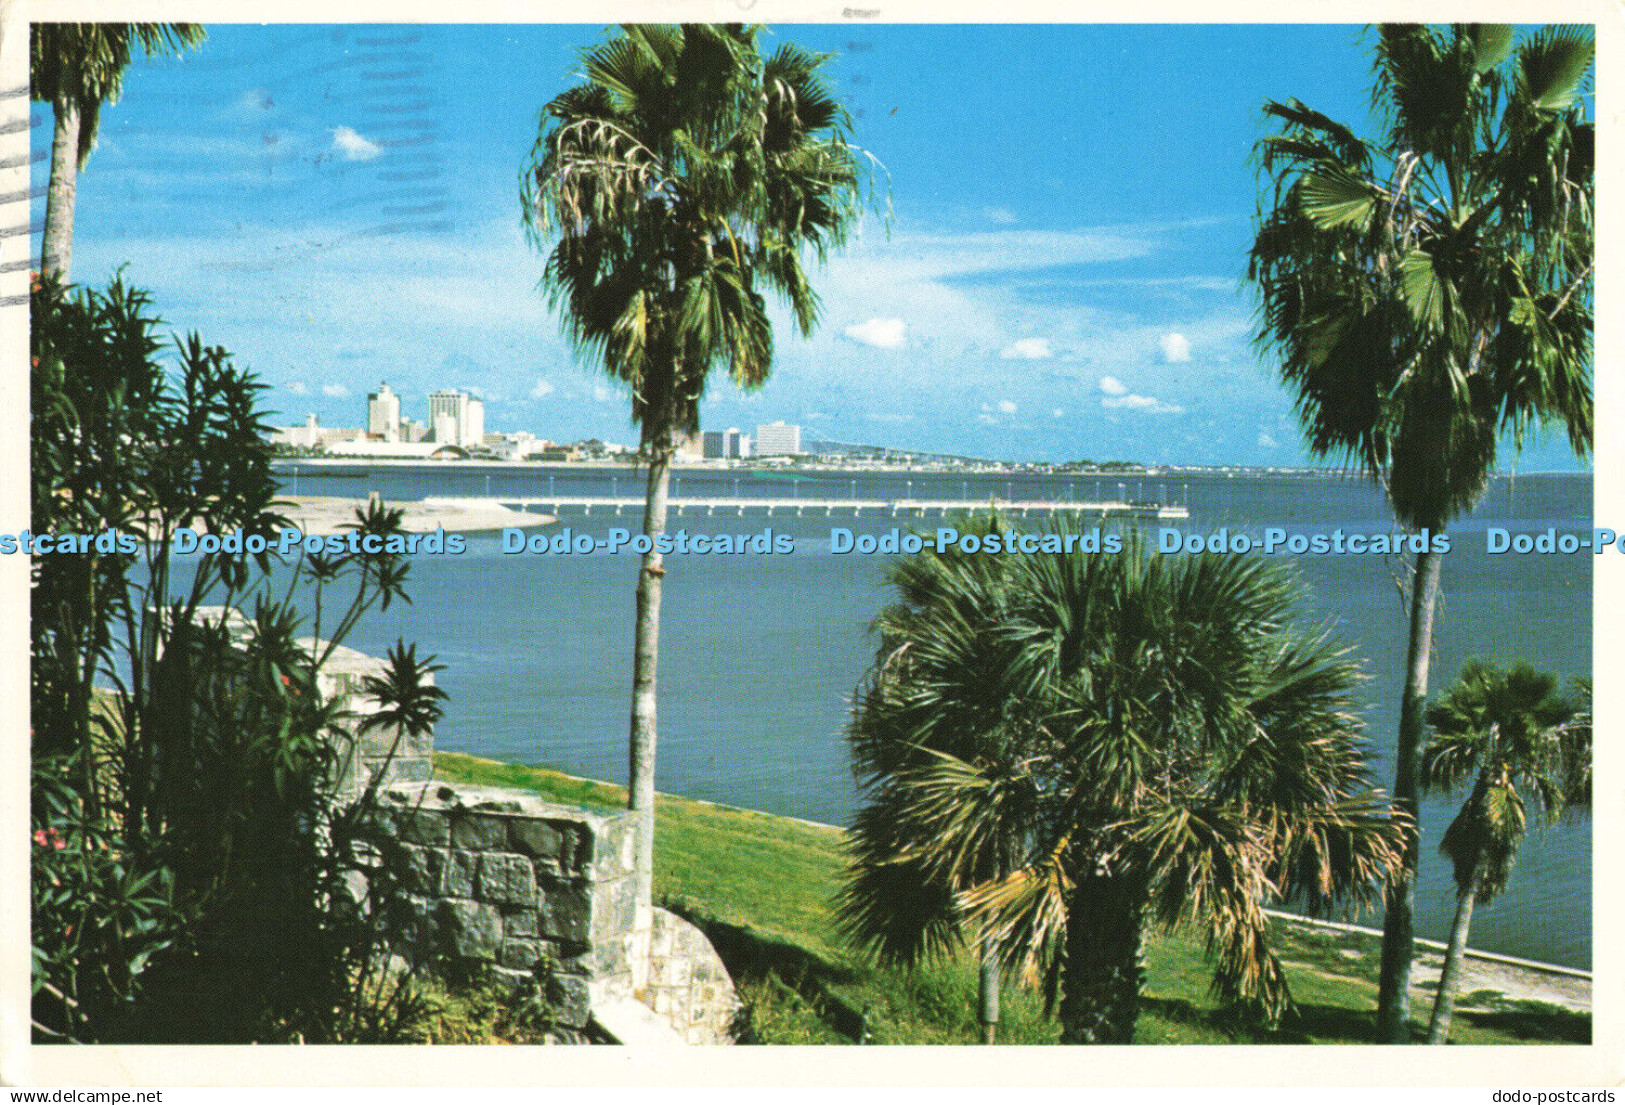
(380, 783, 634, 1029)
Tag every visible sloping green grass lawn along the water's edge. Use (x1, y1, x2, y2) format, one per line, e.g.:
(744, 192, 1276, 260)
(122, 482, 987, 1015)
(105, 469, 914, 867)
(434, 752, 1591, 1043)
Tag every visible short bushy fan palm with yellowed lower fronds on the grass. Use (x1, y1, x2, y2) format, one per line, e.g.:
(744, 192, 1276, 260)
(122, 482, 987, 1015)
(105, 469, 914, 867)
(840, 530, 1401, 1043)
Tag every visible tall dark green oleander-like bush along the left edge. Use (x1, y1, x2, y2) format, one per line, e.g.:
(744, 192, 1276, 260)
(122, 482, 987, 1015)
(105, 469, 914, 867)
(31, 278, 439, 1043)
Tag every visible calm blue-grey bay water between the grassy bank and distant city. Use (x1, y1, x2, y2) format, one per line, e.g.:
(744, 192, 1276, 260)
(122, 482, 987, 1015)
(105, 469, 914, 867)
(284, 466, 1593, 967)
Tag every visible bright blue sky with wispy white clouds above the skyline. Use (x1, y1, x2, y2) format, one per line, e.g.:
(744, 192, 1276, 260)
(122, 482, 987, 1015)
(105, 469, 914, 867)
(33, 24, 1576, 470)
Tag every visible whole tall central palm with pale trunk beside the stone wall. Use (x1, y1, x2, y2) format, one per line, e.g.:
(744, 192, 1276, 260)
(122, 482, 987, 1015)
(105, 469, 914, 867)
(522, 24, 866, 930)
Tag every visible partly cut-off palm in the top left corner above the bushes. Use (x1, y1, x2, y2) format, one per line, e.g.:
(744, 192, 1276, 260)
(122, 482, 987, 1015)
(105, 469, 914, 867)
(28, 23, 203, 283)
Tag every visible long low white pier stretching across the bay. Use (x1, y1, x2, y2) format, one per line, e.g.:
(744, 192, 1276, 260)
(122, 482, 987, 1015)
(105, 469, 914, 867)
(424, 496, 1190, 522)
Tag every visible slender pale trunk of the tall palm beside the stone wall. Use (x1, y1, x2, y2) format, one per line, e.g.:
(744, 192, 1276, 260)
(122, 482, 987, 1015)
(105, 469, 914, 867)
(627, 434, 673, 988)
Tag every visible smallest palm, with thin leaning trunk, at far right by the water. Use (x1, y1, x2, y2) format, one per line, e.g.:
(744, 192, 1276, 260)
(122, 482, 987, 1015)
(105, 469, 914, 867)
(1422, 661, 1591, 1043)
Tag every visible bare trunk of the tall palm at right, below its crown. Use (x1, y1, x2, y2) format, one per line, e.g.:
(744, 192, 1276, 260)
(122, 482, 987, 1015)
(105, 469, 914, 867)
(1376, 542, 1443, 1043)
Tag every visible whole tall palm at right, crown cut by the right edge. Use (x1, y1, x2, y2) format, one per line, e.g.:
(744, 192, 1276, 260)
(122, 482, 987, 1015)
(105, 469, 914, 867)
(1248, 24, 1594, 1043)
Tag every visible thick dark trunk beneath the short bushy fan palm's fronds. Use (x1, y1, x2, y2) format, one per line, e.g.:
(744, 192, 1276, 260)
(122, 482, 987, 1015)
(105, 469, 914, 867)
(1060, 876, 1146, 1043)
